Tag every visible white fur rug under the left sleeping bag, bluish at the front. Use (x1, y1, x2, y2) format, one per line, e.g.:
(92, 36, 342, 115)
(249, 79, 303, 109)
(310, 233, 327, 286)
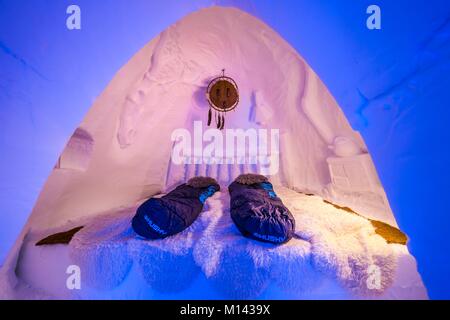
(69, 206, 204, 293)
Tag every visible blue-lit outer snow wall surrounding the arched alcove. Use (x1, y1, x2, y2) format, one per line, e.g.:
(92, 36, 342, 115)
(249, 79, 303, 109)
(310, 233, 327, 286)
(0, 0, 450, 299)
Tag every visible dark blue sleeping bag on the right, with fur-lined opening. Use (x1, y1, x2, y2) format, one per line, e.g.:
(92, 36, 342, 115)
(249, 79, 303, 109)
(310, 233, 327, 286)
(228, 174, 295, 244)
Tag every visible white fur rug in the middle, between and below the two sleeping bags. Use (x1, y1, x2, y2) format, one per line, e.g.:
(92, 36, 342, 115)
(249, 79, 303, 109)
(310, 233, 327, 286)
(194, 192, 318, 299)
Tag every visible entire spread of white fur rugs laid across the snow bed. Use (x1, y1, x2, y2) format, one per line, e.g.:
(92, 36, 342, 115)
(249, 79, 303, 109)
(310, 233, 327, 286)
(59, 188, 397, 299)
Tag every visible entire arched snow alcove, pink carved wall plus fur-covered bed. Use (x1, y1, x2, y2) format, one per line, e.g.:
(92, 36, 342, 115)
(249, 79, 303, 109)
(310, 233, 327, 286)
(2, 7, 427, 298)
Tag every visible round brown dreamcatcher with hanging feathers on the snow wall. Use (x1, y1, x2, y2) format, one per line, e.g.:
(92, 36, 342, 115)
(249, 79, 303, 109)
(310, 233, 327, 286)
(206, 69, 239, 130)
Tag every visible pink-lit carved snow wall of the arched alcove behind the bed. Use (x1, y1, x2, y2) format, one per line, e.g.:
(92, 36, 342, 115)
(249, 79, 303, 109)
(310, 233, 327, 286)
(21, 7, 395, 232)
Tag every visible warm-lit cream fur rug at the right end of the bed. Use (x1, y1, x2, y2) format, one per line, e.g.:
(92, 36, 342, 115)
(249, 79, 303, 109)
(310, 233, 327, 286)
(276, 188, 398, 296)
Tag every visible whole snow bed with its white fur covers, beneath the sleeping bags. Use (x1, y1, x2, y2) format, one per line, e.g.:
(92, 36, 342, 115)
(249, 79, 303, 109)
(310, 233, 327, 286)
(8, 187, 426, 299)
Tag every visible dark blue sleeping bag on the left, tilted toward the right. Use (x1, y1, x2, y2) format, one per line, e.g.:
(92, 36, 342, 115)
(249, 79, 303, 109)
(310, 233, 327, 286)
(132, 177, 220, 239)
